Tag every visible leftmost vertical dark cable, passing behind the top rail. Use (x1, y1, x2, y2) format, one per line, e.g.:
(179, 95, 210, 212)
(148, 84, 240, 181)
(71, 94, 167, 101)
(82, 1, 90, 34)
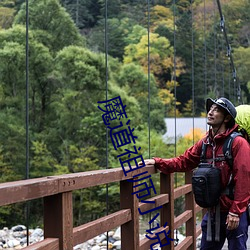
(25, 0, 30, 245)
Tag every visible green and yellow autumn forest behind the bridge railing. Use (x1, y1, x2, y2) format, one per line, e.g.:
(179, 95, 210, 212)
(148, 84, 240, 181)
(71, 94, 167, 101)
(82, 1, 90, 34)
(0, 0, 250, 228)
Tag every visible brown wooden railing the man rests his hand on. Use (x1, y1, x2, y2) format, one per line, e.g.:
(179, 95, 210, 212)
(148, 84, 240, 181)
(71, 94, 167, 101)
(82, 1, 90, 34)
(0, 166, 201, 250)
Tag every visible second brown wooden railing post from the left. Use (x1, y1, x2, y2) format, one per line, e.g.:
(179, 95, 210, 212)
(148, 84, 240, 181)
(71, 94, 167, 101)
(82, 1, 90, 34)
(120, 181, 139, 250)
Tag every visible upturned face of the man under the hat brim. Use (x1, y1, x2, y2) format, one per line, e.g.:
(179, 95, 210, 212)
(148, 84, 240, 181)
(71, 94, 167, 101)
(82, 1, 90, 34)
(207, 104, 225, 128)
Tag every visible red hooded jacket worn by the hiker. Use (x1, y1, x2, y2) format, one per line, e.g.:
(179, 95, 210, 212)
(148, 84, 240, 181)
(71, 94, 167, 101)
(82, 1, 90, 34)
(154, 125, 250, 215)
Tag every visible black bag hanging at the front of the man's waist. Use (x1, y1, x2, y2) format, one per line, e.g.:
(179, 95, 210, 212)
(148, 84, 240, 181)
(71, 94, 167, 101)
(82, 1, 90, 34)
(192, 162, 221, 208)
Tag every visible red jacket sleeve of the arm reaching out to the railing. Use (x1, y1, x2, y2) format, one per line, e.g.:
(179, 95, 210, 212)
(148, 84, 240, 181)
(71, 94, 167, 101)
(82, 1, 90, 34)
(154, 140, 202, 174)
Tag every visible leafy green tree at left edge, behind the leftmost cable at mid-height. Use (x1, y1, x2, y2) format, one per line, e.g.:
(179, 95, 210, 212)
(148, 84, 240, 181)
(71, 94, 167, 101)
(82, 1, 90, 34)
(0, 25, 55, 131)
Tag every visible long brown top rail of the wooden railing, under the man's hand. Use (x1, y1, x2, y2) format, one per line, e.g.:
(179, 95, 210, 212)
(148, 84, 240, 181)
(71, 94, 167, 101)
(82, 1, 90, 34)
(0, 166, 156, 206)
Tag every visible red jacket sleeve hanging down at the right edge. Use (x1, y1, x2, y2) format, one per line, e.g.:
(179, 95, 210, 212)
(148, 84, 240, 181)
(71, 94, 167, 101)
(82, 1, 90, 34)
(229, 136, 250, 215)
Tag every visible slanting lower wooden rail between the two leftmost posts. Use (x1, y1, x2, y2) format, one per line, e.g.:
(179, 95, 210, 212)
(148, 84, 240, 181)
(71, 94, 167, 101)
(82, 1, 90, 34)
(73, 209, 131, 246)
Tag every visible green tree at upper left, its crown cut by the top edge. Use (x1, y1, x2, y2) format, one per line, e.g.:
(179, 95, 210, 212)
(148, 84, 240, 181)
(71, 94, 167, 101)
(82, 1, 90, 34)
(14, 0, 84, 52)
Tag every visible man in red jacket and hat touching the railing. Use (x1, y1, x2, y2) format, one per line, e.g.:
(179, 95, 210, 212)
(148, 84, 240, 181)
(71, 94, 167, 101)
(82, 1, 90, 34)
(141, 97, 250, 250)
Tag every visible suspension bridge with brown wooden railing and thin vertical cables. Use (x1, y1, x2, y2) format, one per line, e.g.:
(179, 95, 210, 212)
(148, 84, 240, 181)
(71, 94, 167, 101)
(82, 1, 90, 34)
(0, 0, 250, 250)
